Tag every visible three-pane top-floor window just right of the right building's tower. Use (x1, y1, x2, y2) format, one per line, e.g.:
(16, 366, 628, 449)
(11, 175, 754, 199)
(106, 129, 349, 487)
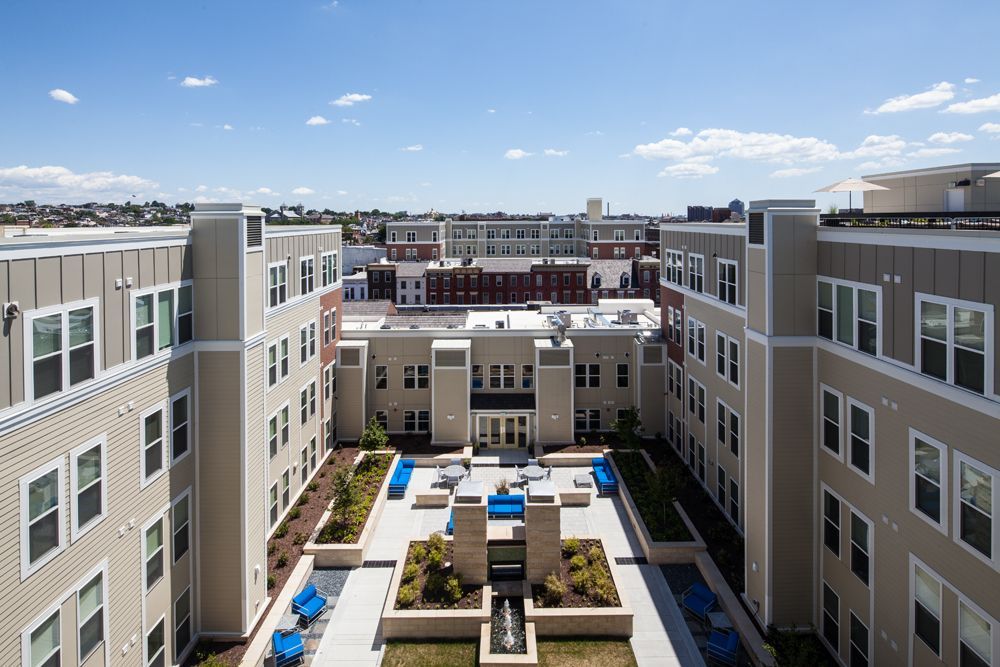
(816, 280, 880, 356)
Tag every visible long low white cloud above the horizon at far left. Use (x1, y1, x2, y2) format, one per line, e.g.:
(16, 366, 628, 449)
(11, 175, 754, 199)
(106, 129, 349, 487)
(0, 164, 159, 201)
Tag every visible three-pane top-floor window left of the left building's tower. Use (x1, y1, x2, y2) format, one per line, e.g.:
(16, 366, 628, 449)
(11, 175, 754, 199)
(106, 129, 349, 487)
(132, 285, 194, 359)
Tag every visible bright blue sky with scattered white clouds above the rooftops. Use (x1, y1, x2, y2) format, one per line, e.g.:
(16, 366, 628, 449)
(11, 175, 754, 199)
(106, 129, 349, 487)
(0, 0, 1000, 214)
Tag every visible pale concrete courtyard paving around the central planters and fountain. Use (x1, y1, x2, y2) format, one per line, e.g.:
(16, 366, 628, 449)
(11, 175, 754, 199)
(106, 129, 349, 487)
(313, 465, 704, 667)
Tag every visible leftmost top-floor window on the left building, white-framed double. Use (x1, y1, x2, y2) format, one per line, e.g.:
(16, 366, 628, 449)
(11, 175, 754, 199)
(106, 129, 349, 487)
(26, 303, 98, 400)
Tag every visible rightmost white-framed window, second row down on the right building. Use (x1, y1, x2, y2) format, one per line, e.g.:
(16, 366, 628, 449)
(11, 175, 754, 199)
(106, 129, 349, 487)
(955, 452, 1000, 560)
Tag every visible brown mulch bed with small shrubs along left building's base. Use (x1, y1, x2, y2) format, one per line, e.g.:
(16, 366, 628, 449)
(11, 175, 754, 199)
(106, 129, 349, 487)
(184, 447, 358, 667)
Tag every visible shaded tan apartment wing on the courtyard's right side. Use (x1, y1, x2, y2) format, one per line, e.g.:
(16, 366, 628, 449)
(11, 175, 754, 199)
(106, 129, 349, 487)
(660, 196, 1000, 665)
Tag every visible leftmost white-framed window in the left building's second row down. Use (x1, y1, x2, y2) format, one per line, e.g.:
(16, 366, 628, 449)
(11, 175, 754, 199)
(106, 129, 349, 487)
(20, 458, 64, 575)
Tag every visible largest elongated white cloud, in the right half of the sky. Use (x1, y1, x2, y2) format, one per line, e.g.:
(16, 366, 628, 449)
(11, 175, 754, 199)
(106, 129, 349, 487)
(634, 128, 838, 164)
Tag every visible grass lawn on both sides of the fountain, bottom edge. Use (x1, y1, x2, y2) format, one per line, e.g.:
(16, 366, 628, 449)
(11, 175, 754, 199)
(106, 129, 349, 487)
(382, 639, 636, 667)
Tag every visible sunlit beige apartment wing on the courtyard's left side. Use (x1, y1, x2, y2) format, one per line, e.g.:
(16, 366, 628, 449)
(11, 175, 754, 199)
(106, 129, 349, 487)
(0, 204, 342, 665)
